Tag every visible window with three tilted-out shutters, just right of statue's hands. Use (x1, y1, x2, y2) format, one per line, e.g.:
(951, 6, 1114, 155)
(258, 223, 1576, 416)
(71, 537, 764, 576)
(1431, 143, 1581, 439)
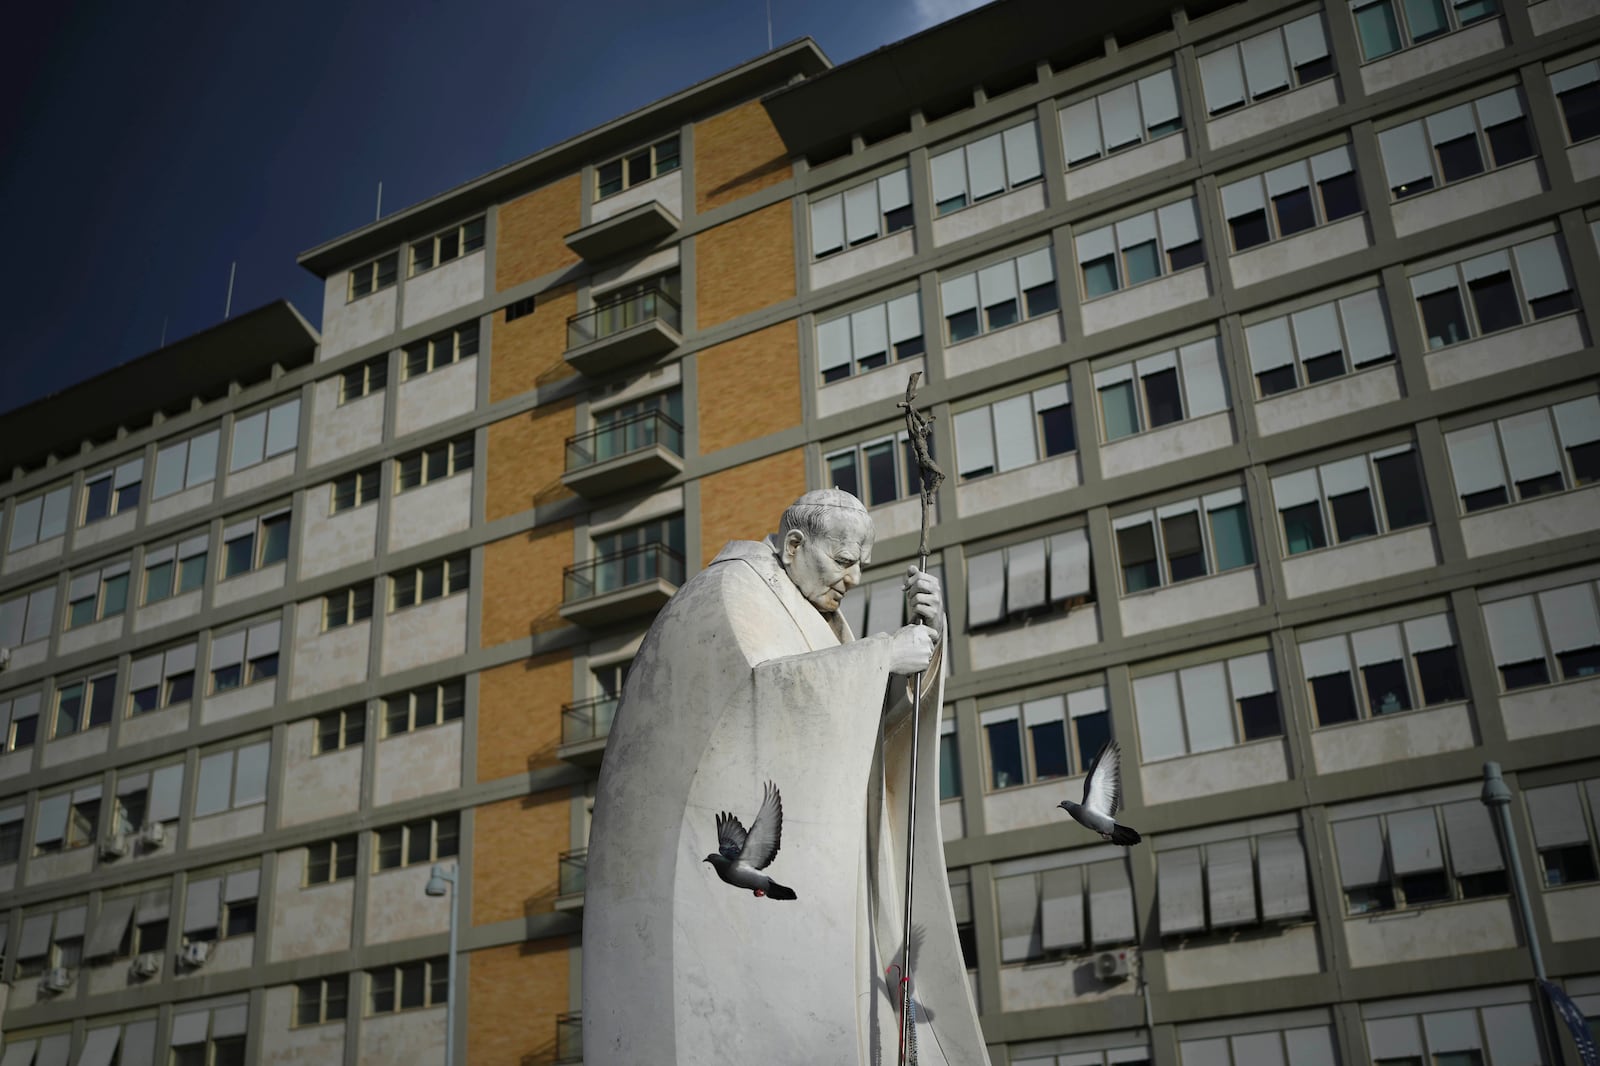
(966, 530, 1094, 629)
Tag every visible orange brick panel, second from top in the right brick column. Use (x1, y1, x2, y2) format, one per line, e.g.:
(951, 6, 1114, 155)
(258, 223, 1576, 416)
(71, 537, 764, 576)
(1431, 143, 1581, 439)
(694, 200, 795, 330)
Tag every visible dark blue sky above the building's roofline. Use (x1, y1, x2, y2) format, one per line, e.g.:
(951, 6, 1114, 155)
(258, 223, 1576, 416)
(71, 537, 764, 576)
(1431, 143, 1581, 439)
(0, 0, 979, 410)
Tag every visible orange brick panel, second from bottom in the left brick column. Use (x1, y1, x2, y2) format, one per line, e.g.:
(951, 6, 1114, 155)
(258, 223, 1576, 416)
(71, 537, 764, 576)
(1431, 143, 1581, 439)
(472, 789, 573, 925)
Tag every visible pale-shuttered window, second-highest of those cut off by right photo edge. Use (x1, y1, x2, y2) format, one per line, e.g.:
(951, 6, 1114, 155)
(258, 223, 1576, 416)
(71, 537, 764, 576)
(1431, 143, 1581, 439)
(1445, 395, 1600, 514)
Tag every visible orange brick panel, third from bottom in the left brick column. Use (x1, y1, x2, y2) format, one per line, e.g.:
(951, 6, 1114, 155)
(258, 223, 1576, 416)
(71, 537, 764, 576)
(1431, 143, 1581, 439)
(478, 651, 573, 781)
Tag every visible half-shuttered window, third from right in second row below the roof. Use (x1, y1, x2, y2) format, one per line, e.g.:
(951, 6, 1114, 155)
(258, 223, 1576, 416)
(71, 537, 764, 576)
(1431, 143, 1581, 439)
(1222, 144, 1362, 251)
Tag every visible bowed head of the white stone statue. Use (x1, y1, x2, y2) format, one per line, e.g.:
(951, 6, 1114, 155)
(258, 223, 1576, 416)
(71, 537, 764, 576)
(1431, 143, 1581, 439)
(778, 488, 875, 615)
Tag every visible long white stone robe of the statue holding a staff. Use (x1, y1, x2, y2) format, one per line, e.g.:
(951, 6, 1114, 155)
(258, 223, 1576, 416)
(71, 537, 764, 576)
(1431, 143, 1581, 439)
(582, 538, 989, 1066)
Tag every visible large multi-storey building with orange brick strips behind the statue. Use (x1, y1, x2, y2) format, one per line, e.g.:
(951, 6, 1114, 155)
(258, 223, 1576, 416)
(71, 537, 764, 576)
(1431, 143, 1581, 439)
(0, 0, 1600, 1066)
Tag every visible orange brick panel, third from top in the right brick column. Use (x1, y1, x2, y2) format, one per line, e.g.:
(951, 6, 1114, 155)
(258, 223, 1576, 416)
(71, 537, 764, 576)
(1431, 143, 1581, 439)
(696, 313, 800, 455)
